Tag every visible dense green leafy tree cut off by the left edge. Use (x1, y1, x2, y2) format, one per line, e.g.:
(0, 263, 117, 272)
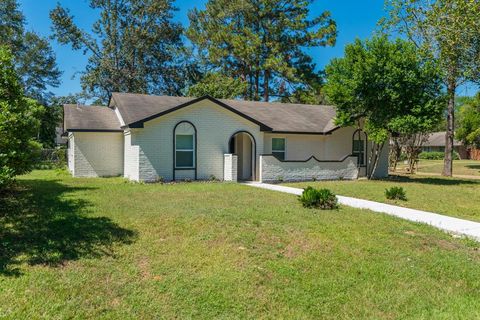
(0, 47, 43, 190)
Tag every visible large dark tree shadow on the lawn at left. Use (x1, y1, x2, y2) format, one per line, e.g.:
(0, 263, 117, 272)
(0, 180, 136, 276)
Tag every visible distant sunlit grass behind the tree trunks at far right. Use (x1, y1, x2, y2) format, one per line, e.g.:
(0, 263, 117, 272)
(397, 160, 480, 178)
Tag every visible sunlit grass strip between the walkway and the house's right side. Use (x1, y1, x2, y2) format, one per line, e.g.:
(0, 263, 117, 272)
(287, 175, 480, 221)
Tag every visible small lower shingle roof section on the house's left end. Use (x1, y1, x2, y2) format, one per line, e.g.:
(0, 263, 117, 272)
(63, 104, 122, 131)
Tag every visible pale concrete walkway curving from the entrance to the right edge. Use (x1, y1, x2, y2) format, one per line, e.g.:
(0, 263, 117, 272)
(245, 182, 480, 241)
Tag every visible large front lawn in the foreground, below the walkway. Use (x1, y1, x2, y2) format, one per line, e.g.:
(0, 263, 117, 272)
(0, 171, 480, 319)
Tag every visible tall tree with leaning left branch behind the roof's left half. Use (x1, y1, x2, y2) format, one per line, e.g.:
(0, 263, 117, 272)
(50, 0, 188, 103)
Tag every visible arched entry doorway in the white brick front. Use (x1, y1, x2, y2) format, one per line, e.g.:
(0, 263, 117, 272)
(228, 131, 257, 181)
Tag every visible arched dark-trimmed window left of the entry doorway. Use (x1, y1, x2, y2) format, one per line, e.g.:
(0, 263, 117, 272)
(173, 121, 197, 170)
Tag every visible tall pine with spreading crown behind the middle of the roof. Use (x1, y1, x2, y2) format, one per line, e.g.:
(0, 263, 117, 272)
(187, 0, 337, 101)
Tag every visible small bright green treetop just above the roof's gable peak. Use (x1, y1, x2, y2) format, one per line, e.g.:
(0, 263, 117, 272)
(187, 73, 247, 99)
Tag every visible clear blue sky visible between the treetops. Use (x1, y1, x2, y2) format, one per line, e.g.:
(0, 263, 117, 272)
(15, 0, 474, 96)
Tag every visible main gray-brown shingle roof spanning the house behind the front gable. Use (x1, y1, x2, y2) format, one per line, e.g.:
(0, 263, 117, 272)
(110, 93, 338, 134)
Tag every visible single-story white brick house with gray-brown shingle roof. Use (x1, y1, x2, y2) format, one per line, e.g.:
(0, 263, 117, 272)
(64, 93, 388, 182)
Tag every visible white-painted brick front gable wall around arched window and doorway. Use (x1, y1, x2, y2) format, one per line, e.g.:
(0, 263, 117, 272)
(125, 100, 263, 181)
